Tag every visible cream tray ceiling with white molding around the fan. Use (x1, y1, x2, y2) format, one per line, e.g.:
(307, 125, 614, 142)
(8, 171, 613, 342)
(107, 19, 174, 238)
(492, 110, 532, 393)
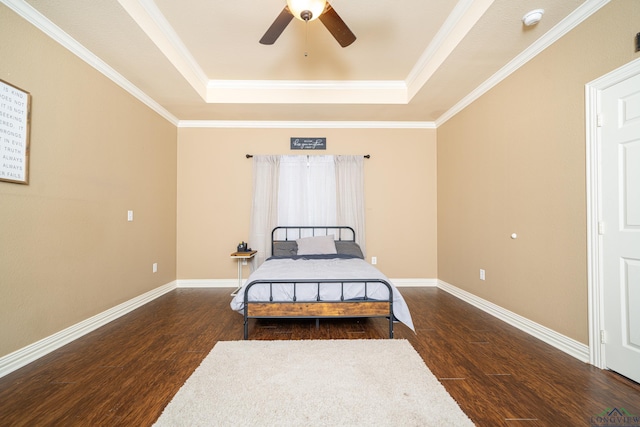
(10, 0, 608, 125)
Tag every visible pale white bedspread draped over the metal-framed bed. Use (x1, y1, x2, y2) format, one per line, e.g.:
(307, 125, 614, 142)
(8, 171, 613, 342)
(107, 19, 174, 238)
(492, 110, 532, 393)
(231, 258, 414, 330)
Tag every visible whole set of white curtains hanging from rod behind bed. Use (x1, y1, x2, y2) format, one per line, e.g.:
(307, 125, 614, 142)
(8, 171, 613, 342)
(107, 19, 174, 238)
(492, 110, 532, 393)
(249, 155, 365, 270)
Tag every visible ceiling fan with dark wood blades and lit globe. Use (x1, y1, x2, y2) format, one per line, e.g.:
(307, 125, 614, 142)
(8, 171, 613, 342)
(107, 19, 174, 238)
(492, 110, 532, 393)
(260, 0, 356, 47)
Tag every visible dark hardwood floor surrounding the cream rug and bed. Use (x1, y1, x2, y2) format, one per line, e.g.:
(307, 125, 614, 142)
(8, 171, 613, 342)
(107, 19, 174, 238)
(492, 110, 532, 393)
(0, 288, 640, 426)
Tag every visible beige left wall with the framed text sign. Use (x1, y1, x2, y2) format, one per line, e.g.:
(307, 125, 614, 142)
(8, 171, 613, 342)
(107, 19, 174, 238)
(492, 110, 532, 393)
(0, 5, 177, 356)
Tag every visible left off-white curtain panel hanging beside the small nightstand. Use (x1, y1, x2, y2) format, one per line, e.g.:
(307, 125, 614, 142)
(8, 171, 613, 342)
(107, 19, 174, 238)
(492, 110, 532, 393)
(249, 156, 280, 271)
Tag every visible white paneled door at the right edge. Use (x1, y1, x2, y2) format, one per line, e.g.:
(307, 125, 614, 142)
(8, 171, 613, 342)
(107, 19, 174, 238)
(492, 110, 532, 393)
(600, 75, 640, 382)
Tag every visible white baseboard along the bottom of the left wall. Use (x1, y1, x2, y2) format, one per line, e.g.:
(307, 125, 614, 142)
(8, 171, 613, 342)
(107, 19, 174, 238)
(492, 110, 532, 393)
(0, 282, 176, 378)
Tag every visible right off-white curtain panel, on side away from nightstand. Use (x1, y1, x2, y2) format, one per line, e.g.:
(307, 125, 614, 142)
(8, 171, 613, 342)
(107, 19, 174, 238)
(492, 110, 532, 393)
(335, 156, 366, 256)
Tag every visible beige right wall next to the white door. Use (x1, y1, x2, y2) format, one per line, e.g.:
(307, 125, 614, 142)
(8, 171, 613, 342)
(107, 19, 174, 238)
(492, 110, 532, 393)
(437, 0, 640, 344)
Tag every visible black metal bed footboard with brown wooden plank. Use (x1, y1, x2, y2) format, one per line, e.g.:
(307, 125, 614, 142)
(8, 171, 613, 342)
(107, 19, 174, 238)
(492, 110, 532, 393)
(243, 279, 394, 340)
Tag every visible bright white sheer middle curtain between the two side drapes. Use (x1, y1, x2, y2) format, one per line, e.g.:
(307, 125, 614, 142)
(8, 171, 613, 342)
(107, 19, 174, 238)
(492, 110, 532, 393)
(278, 156, 337, 236)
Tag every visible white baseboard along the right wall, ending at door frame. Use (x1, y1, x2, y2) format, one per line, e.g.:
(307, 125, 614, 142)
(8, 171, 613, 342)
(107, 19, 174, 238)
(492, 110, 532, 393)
(438, 280, 589, 363)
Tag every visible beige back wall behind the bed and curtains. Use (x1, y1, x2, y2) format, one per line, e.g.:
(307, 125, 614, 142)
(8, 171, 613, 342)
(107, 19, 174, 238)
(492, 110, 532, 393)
(177, 128, 437, 279)
